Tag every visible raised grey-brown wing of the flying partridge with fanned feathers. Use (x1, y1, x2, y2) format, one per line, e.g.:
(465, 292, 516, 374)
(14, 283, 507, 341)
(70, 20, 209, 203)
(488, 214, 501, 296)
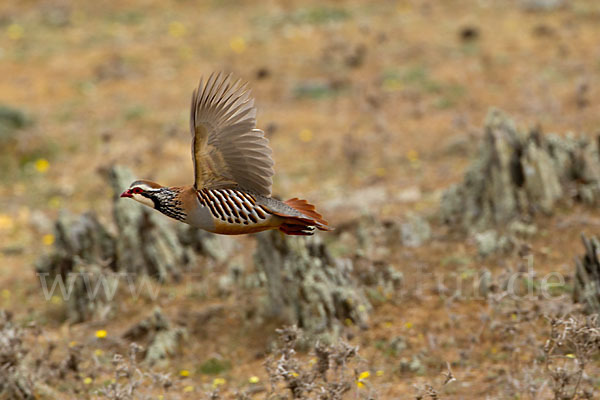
(190, 73, 274, 196)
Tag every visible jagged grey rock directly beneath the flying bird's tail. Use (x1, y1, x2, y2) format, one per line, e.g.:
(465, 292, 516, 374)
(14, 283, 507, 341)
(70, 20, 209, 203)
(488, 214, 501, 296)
(254, 231, 371, 340)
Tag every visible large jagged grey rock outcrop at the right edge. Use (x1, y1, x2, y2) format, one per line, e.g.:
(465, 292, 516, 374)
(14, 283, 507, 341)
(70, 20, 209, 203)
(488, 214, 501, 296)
(440, 110, 600, 234)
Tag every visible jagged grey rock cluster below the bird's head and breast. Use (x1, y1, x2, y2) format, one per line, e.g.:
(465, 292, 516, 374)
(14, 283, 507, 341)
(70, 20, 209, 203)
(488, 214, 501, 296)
(36, 166, 234, 322)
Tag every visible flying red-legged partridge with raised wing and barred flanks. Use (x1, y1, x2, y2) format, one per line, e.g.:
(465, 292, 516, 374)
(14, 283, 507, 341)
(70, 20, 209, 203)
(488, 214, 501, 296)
(121, 73, 331, 235)
